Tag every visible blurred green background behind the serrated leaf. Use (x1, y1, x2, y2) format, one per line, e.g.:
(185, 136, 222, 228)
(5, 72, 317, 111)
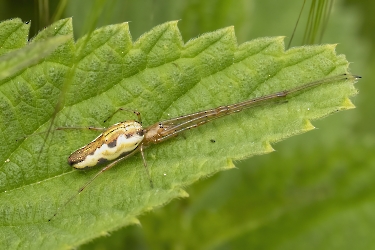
(0, 0, 375, 249)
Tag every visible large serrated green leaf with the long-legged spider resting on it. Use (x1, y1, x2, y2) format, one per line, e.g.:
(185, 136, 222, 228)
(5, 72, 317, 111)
(0, 19, 356, 249)
